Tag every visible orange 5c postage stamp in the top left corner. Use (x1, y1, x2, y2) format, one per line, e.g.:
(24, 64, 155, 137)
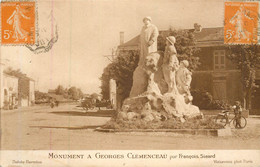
(1, 1, 35, 45)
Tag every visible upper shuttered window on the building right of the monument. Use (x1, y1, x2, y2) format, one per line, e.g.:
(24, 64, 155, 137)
(213, 50, 226, 70)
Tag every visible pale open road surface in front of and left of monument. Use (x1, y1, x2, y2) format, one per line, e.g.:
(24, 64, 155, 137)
(1, 105, 260, 150)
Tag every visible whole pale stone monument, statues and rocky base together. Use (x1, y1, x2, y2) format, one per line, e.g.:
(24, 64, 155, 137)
(118, 17, 202, 122)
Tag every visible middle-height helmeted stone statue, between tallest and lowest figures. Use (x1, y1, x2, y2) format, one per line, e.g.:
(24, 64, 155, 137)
(162, 36, 179, 93)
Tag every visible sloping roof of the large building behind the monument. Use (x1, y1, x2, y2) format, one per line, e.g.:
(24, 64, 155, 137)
(119, 27, 224, 48)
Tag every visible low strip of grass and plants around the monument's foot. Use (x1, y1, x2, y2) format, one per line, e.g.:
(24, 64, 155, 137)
(103, 116, 224, 130)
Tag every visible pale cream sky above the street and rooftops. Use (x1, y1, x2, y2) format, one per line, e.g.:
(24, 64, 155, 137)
(1, 0, 224, 93)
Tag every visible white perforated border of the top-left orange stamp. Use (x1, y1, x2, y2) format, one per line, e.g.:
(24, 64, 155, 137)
(0, 0, 39, 46)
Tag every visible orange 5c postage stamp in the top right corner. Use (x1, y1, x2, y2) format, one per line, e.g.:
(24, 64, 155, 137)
(224, 2, 258, 44)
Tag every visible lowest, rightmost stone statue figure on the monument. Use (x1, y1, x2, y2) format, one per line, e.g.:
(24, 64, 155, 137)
(176, 60, 193, 102)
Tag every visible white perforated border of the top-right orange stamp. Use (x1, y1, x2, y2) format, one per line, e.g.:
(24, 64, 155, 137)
(222, 0, 260, 45)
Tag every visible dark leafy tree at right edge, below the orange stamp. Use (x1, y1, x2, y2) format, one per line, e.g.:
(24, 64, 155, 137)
(228, 45, 260, 109)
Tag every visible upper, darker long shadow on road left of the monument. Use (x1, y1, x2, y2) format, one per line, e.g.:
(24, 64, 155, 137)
(51, 110, 116, 117)
